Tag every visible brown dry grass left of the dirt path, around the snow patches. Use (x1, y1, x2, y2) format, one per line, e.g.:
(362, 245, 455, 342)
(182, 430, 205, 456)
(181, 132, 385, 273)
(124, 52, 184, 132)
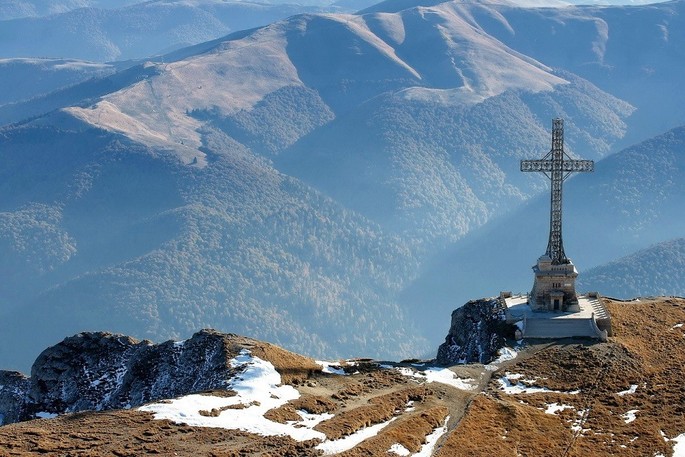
(0, 360, 473, 457)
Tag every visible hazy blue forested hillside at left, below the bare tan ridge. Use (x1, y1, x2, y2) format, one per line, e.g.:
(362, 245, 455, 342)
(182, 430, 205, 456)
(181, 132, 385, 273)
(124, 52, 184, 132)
(0, 121, 428, 369)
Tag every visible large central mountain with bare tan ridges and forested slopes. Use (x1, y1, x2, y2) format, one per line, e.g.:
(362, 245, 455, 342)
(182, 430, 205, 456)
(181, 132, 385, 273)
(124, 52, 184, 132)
(2, 3, 677, 370)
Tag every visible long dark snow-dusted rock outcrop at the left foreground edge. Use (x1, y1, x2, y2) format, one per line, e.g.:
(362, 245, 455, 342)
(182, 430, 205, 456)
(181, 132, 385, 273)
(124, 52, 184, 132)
(0, 330, 320, 424)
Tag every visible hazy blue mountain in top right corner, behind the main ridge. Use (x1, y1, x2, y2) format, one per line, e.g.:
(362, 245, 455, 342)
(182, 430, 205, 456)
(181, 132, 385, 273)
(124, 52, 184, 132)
(444, 0, 685, 147)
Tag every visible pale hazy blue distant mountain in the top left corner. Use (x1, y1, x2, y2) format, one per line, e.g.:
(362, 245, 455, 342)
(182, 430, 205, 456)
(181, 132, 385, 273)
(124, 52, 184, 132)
(0, 0, 334, 62)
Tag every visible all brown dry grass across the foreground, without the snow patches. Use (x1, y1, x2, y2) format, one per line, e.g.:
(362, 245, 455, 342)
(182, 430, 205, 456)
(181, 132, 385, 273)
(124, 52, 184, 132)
(0, 299, 685, 457)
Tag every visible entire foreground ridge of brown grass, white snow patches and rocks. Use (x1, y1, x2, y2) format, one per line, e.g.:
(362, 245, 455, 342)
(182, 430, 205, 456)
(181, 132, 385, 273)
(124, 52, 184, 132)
(0, 297, 685, 457)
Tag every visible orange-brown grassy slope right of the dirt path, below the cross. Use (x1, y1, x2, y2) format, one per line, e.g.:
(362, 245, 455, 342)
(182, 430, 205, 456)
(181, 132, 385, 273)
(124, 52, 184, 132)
(438, 299, 685, 457)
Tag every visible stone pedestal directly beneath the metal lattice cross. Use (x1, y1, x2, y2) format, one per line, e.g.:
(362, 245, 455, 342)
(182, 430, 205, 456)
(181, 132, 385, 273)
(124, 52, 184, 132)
(530, 255, 580, 312)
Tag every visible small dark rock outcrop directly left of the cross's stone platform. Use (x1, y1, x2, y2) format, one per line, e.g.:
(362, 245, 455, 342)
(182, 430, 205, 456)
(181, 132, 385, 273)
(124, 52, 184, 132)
(436, 298, 514, 365)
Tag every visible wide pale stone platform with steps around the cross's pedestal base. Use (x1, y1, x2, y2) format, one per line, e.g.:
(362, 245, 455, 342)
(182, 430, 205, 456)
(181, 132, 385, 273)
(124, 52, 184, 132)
(500, 292, 611, 341)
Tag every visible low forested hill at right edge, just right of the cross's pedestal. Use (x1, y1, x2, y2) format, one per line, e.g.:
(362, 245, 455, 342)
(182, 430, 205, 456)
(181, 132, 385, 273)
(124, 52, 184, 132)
(578, 238, 685, 299)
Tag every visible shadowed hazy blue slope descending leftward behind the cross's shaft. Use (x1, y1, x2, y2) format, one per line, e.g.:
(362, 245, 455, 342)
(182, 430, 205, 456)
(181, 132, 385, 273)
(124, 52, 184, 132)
(405, 123, 685, 334)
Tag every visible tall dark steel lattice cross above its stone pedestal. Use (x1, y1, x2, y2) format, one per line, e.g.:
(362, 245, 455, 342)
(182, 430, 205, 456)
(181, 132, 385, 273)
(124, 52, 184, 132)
(521, 118, 595, 265)
